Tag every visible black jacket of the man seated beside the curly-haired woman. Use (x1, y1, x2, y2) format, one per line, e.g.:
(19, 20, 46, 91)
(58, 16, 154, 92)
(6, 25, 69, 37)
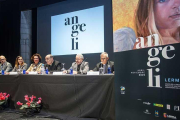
(44, 60, 61, 72)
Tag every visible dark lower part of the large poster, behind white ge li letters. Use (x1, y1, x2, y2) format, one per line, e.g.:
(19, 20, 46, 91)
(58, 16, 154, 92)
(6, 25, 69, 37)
(114, 43, 180, 120)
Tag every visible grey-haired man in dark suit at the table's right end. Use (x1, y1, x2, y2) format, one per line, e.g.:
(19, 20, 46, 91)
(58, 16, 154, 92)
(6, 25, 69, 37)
(93, 52, 114, 73)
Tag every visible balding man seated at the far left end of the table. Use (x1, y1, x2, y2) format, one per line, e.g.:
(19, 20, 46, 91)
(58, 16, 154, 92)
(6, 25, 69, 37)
(0, 55, 13, 73)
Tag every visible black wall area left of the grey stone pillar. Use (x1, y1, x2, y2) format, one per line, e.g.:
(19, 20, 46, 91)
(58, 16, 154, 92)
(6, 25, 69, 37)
(0, 0, 20, 66)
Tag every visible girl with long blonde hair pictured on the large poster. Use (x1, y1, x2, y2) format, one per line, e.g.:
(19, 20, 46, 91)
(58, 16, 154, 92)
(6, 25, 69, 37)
(134, 0, 180, 49)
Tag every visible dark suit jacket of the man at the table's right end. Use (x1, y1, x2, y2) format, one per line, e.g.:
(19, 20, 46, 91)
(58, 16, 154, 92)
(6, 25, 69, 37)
(93, 61, 114, 73)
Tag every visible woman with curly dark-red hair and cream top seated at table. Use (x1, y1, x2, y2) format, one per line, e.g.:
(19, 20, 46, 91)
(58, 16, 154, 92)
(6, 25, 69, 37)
(26, 53, 42, 74)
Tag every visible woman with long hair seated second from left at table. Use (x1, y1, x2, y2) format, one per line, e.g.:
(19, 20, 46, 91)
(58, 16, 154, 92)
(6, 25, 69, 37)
(12, 56, 27, 72)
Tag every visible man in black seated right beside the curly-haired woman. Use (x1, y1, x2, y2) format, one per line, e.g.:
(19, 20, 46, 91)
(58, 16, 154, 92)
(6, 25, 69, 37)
(44, 54, 61, 72)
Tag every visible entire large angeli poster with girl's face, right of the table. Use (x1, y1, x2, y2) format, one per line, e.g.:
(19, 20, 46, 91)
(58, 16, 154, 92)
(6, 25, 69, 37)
(113, 0, 180, 120)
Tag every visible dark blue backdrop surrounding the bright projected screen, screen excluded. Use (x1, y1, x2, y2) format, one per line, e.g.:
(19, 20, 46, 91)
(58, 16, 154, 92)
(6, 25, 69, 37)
(37, 0, 113, 69)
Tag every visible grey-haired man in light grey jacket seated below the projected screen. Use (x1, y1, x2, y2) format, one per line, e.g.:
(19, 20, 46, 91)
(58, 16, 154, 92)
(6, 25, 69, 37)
(64, 54, 89, 74)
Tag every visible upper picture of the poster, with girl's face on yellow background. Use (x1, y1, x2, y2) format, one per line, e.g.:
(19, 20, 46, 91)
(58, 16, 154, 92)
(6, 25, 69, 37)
(113, 0, 180, 52)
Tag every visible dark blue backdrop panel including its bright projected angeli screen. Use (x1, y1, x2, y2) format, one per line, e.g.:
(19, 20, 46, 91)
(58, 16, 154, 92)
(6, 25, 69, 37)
(37, 0, 113, 70)
